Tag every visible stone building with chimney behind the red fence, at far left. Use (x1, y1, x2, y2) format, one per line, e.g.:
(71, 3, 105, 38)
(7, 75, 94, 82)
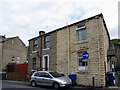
(0, 36, 27, 70)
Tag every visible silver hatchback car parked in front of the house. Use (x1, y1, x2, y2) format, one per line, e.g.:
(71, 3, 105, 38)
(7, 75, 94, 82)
(30, 71, 72, 88)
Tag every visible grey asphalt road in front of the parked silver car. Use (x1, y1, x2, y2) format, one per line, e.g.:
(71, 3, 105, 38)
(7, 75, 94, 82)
(2, 80, 120, 90)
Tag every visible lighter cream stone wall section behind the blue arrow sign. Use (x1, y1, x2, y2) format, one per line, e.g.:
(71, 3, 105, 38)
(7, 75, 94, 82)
(57, 17, 109, 86)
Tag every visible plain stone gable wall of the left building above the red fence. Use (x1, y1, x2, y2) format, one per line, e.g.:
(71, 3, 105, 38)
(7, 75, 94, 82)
(2, 37, 27, 68)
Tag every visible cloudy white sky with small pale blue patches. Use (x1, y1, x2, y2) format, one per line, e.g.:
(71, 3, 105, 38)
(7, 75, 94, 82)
(0, 0, 119, 45)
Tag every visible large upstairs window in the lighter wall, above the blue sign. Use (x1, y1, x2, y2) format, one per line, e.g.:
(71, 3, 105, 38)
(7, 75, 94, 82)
(76, 24, 87, 41)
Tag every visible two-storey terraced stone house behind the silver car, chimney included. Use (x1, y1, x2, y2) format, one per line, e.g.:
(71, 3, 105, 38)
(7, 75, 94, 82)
(28, 14, 110, 87)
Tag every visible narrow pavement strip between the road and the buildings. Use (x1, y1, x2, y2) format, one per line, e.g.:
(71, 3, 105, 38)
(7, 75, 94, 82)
(1, 80, 120, 90)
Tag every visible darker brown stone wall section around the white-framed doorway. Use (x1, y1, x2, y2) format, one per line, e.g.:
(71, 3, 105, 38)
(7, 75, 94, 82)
(28, 32, 57, 73)
